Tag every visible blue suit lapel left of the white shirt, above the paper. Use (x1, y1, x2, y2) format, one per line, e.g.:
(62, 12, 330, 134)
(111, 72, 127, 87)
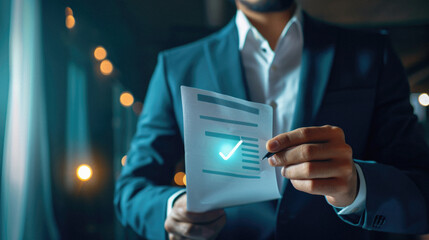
(204, 18, 249, 100)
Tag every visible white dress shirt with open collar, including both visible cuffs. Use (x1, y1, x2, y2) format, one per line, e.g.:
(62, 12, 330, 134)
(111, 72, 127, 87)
(167, 8, 366, 216)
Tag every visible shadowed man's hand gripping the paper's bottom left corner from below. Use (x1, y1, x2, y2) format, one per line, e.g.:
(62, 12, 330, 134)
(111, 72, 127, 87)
(164, 194, 226, 240)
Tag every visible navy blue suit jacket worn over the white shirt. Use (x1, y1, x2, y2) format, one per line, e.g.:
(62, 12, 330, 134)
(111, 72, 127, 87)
(115, 15, 429, 239)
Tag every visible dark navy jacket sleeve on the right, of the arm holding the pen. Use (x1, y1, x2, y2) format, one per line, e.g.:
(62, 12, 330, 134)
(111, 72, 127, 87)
(340, 36, 429, 234)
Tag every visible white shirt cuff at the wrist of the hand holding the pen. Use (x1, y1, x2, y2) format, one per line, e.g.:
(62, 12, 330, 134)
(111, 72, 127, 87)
(328, 163, 366, 215)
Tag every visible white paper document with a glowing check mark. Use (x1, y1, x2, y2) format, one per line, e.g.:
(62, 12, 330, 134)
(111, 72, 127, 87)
(181, 86, 282, 212)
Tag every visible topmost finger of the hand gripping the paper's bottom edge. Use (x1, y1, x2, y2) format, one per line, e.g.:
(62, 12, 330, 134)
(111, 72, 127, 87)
(171, 207, 225, 223)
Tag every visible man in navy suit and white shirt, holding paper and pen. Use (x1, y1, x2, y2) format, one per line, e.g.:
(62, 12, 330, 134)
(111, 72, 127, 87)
(115, 0, 429, 239)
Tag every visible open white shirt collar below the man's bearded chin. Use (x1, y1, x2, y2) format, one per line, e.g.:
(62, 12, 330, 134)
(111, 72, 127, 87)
(235, 5, 303, 50)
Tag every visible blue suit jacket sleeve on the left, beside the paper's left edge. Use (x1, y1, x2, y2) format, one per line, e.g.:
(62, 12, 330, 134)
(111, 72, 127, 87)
(114, 54, 184, 239)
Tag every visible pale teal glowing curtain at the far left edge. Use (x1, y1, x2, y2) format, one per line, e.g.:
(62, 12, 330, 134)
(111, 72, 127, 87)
(0, 0, 59, 240)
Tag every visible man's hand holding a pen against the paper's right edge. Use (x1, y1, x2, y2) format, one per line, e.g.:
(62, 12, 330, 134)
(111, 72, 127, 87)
(266, 126, 357, 207)
